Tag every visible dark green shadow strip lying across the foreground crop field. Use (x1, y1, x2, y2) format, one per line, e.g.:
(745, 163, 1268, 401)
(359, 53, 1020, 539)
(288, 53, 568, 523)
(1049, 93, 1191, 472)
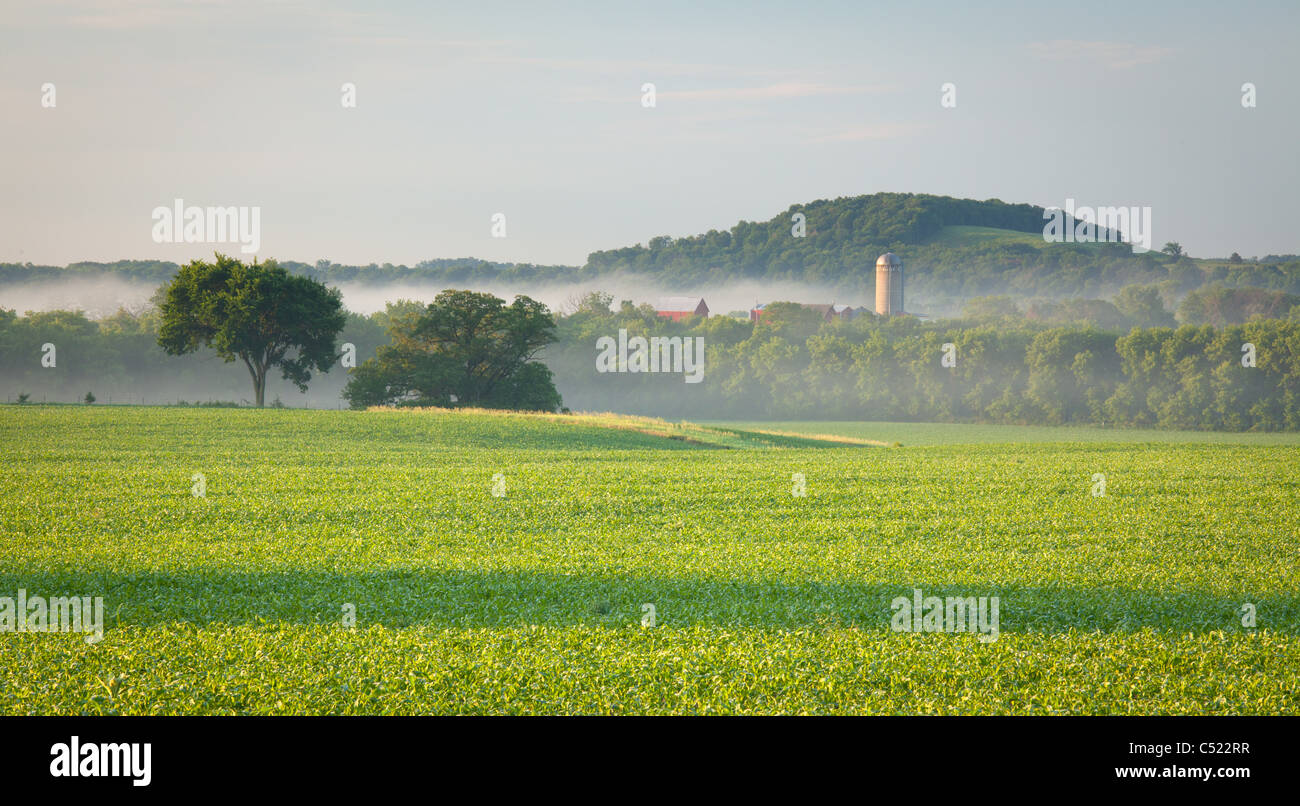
(0, 569, 1300, 633)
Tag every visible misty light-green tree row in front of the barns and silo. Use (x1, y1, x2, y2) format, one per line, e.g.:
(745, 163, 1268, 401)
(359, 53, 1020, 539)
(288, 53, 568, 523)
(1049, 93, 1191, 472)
(545, 295, 1300, 430)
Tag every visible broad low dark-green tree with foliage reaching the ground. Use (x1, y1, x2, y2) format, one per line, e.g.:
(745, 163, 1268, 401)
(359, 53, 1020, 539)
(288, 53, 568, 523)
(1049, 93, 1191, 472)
(343, 290, 560, 411)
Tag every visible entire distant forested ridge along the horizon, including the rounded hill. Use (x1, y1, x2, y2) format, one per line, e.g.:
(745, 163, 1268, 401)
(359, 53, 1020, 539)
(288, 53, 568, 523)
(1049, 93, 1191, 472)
(10, 192, 1300, 309)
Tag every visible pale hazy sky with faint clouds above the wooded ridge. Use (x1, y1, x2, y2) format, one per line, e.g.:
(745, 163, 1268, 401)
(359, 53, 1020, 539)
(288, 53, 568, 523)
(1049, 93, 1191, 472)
(0, 0, 1300, 264)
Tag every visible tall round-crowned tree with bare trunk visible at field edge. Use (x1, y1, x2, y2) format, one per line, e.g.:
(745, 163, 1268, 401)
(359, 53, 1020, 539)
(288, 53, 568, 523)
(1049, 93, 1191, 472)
(159, 255, 347, 407)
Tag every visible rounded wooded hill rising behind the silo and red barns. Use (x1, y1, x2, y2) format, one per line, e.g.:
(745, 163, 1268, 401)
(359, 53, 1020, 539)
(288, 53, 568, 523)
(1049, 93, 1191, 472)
(584, 192, 1300, 313)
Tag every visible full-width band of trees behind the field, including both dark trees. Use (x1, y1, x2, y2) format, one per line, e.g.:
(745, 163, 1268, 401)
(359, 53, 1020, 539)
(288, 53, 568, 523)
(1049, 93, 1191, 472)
(0, 261, 1300, 430)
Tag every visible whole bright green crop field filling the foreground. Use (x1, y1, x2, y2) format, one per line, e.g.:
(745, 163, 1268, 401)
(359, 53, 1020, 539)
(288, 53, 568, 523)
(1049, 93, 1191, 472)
(0, 406, 1300, 714)
